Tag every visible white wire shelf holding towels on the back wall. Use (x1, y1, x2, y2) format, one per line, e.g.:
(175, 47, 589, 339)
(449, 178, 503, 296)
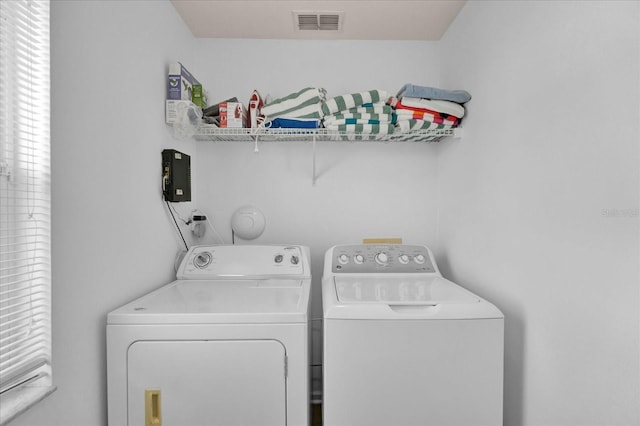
(194, 125, 461, 142)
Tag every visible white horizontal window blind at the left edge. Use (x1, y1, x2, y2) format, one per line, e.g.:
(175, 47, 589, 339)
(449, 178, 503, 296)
(0, 0, 51, 423)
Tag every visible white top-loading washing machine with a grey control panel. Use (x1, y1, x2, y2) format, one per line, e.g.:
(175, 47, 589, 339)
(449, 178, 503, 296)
(322, 244, 504, 426)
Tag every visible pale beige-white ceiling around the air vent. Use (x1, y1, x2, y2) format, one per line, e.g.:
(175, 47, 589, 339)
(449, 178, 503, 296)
(171, 0, 466, 41)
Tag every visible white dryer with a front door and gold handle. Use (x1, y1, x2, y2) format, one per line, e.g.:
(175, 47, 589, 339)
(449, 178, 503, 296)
(107, 245, 311, 426)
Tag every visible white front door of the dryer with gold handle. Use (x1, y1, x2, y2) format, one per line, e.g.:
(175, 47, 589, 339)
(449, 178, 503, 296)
(127, 340, 286, 426)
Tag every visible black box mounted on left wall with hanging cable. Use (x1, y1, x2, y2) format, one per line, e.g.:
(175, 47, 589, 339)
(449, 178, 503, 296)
(162, 149, 191, 202)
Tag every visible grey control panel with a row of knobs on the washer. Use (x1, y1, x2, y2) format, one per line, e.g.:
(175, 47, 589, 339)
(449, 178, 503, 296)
(331, 244, 436, 274)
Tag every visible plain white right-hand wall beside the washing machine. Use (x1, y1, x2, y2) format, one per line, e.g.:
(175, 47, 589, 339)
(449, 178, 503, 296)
(438, 1, 640, 426)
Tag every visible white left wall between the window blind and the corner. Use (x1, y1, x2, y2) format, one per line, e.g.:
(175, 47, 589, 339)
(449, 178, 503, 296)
(12, 0, 193, 426)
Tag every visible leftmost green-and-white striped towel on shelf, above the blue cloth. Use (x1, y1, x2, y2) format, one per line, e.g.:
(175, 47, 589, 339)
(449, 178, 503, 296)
(260, 87, 327, 121)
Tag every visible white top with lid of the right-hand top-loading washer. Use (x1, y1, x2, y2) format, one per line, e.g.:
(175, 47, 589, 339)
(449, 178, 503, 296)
(323, 274, 502, 319)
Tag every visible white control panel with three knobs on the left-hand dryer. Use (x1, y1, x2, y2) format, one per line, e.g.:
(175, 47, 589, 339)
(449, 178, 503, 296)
(177, 245, 309, 279)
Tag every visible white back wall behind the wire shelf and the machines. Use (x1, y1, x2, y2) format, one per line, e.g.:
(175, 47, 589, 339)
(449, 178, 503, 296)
(189, 39, 439, 393)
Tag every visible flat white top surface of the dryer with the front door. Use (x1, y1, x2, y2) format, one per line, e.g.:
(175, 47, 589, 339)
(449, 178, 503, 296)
(107, 279, 310, 324)
